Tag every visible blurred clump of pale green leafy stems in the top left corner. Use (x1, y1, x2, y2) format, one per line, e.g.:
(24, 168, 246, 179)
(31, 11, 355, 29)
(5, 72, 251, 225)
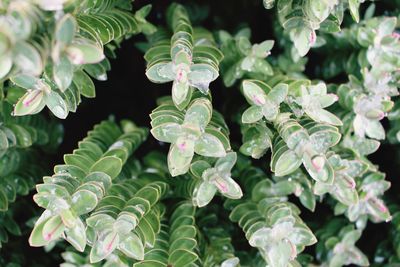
(0, 1, 155, 119)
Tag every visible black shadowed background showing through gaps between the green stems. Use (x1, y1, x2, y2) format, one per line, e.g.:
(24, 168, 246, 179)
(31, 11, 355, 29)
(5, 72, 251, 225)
(0, 0, 400, 267)
